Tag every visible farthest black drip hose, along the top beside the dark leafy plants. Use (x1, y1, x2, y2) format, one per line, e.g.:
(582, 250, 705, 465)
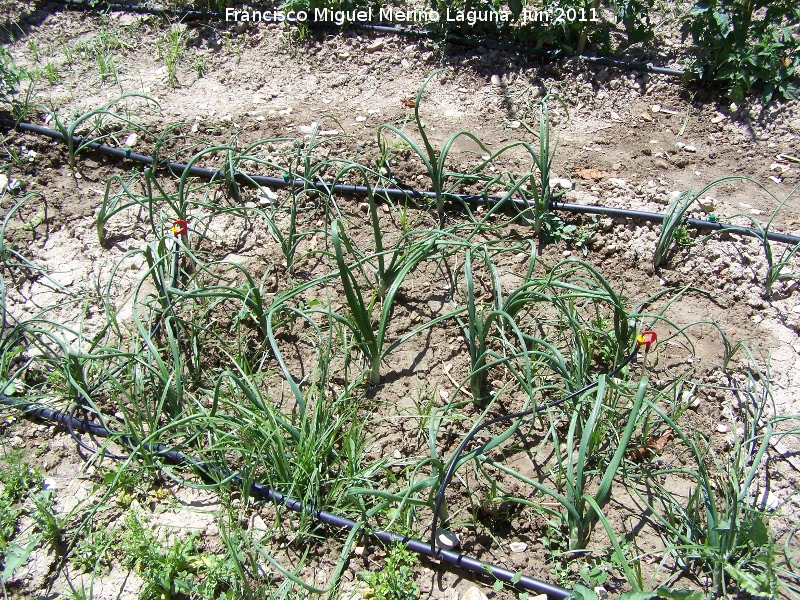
(58, 0, 685, 77)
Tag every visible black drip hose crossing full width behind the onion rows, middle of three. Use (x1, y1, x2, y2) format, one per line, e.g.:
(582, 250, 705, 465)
(0, 119, 800, 245)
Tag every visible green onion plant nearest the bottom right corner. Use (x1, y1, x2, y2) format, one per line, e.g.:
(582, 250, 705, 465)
(633, 368, 778, 598)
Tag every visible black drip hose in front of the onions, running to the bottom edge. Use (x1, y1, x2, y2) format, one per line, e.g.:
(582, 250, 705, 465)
(0, 393, 570, 599)
